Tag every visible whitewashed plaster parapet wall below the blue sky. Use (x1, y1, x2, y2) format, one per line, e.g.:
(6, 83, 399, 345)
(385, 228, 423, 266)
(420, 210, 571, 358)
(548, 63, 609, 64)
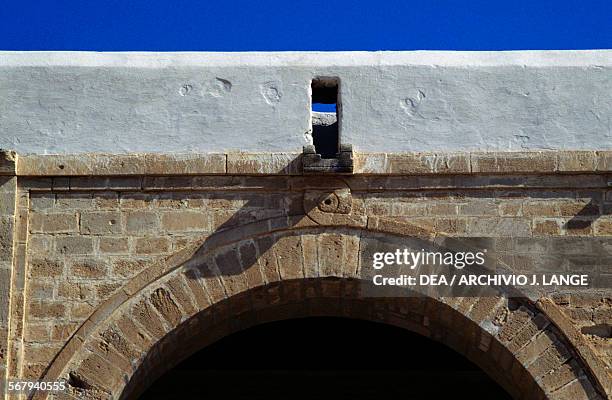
(0, 50, 612, 154)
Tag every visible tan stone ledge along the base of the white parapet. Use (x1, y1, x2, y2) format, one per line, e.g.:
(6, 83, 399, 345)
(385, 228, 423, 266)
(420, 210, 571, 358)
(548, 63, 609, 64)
(11, 151, 612, 176)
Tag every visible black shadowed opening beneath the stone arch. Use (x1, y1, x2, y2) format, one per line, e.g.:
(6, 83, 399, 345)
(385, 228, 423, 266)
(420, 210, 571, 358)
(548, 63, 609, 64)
(140, 317, 510, 400)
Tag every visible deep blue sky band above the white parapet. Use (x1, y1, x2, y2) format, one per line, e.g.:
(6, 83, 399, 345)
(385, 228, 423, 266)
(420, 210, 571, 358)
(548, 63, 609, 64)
(0, 0, 612, 51)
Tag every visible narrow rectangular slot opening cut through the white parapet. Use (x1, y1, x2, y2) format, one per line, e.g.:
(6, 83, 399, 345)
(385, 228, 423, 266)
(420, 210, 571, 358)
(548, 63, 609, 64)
(311, 78, 340, 158)
